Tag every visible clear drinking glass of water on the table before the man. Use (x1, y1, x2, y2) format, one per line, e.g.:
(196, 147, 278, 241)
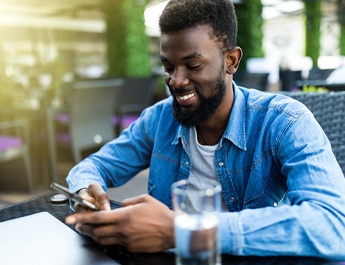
(172, 177, 221, 265)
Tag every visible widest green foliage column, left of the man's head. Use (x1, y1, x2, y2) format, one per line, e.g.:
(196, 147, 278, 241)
(103, 0, 151, 77)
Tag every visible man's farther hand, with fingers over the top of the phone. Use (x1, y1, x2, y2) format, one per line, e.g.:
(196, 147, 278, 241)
(74, 182, 111, 212)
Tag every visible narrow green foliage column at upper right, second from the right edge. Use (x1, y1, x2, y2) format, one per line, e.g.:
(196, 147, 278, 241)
(304, 0, 321, 65)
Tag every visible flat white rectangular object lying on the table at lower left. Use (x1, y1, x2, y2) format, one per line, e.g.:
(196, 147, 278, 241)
(0, 212, 119, 265)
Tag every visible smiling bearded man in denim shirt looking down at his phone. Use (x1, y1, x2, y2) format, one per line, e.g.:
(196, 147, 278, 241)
(66, 0, 345, 258)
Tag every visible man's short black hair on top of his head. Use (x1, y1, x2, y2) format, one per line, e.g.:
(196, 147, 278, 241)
(159, 0, 237, 52)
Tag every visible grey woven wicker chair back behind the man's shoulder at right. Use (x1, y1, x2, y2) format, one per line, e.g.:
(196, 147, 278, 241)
(284, 91, 345, 173)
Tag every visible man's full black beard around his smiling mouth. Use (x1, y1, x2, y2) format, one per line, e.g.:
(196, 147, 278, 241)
(172, 76, 226, 127)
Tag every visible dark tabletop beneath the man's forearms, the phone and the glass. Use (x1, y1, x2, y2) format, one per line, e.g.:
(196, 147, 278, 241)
(0, 193, 345, 265)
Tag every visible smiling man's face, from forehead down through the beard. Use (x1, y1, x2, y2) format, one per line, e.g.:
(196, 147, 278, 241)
(161, 26, 226, 126)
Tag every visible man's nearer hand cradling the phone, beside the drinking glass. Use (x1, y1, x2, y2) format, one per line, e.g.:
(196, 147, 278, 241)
(66, 192, 174, 252)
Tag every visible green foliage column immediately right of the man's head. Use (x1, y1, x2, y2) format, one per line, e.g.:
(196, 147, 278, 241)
(235, 0, 264, 69)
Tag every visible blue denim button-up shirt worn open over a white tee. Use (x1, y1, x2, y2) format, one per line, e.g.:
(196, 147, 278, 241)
(67, 83, 345, 259)
